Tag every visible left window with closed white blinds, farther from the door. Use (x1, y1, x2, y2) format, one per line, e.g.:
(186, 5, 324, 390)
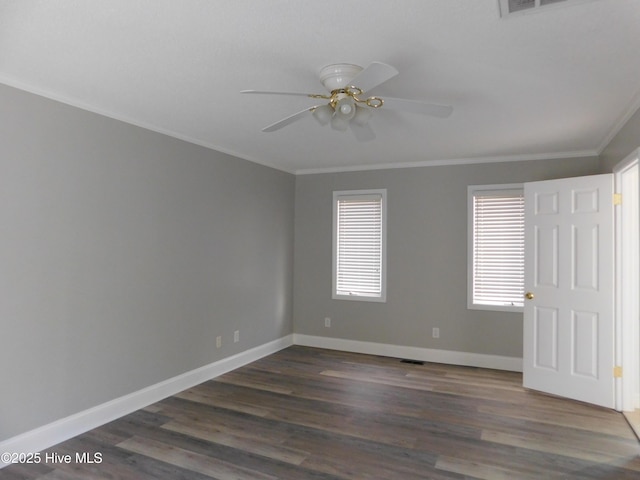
(333, 190, 387, 302)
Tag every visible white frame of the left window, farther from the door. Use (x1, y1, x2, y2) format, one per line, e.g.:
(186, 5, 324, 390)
(332, 189, 387, 302)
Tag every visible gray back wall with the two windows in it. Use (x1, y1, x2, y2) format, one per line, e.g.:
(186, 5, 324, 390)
(294, 157, 600, 357)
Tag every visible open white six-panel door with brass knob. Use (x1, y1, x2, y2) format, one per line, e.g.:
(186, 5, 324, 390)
(523, 174, 614, 408)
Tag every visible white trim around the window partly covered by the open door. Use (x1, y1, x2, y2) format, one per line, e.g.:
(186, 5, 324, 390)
(467, 183, 524, 313)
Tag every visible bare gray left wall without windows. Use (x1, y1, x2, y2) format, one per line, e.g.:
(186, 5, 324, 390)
(0, 86, 295, 441)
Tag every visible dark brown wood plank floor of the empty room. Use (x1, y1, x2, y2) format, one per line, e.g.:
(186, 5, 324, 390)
(5, 346, 640, 480)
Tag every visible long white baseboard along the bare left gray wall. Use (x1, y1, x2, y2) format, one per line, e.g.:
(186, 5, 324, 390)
(0, 335, 293, 469)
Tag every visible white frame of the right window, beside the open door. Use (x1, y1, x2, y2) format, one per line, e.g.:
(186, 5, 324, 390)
(467, 183, 524, 312)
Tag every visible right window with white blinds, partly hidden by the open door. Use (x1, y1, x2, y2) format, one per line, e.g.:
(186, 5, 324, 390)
(467, 185, 524, 311)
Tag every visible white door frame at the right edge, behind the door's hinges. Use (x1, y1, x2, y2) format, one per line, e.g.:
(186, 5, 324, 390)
(613, 148, 640, 411)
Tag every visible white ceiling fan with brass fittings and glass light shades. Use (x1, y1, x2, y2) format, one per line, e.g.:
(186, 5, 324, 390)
(240, 62, 453, 141)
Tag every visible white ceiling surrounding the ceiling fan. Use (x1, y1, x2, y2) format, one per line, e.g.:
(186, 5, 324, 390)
(0, 0, 640, 173)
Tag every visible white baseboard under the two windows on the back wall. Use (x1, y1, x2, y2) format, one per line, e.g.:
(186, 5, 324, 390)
(293, 333, 522, 372)
